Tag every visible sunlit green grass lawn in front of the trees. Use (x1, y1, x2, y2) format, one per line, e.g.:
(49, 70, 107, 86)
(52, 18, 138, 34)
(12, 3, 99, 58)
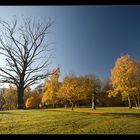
(0, 107, 140, 134)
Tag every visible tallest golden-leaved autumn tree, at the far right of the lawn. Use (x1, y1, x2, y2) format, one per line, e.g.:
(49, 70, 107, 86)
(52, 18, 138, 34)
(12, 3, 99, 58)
(109, 55, 138, 108)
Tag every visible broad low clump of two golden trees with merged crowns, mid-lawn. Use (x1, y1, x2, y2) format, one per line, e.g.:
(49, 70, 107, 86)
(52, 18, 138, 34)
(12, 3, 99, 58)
(57, 75, 99, 110)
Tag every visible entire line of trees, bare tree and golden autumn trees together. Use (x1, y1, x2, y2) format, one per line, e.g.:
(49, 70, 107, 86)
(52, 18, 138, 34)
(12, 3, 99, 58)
(0, 17, 140, 110)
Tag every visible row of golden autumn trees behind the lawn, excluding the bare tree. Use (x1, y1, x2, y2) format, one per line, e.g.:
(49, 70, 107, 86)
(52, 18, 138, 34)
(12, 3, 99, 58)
(0, 55, 140, 110)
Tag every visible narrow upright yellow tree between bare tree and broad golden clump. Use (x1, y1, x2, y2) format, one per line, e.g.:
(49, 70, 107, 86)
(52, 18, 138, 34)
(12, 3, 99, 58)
(42, 68, 60, 107)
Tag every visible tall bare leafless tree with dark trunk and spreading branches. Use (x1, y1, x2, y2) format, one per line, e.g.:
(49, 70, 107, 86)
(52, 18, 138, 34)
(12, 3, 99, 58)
(0, 17, 52, 109)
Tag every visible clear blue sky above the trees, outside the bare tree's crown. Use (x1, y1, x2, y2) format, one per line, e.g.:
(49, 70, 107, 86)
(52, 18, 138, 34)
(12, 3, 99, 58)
(0, 6, 140, 80)
